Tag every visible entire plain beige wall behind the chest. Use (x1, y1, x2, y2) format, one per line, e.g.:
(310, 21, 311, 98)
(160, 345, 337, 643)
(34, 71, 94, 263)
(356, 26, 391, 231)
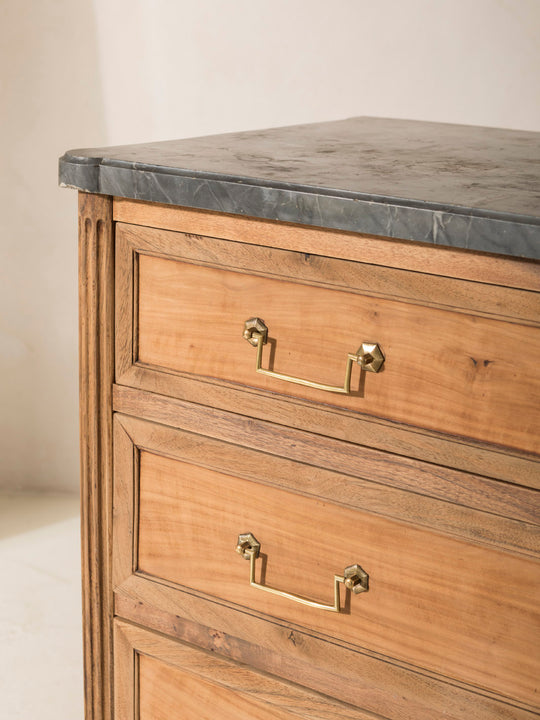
(0, 0, 540, 489)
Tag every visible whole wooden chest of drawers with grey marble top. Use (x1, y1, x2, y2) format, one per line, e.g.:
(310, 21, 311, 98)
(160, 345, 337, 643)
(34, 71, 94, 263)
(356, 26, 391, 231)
(60, 119, 540, 720)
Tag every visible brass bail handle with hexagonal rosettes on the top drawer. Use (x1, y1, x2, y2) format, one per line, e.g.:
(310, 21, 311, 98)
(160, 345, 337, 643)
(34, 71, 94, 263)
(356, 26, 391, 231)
(244, 318, 384, 395)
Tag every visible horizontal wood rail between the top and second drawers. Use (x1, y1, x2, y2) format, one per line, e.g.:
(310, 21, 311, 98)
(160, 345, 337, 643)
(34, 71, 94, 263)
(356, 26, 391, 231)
(113, 382, 540, 490)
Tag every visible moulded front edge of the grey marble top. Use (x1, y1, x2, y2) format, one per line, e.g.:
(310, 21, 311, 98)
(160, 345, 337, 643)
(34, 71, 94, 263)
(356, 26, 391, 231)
(59, 151, 540, 259)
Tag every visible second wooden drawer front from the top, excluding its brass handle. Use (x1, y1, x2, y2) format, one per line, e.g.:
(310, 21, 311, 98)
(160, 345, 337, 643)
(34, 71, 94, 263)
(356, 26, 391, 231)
(113, 410, 540, 705)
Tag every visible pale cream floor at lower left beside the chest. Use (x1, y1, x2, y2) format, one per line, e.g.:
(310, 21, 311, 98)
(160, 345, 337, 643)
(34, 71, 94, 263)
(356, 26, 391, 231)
(0, 492, 84, 720)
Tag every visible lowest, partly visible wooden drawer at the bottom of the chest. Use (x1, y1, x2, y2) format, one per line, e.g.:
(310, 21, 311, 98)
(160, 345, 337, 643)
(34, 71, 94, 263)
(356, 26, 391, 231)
(114, 621, 374, 720)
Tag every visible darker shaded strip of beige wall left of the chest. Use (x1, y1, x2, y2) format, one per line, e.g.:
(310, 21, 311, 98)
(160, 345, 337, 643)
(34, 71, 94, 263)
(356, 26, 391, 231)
(0, 0, 105, 491)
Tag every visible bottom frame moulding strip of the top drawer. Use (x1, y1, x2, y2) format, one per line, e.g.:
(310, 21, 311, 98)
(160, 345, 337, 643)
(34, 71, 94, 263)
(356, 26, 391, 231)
(117, 364, 540, 490)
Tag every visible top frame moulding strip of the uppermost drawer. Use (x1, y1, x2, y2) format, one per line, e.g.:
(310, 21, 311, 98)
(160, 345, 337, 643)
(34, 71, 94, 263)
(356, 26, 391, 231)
(116, 223, 540, 326)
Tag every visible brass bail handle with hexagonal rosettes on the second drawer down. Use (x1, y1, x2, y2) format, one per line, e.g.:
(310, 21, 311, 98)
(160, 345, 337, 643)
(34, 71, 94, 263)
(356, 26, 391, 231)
(236, 533, 369, 612)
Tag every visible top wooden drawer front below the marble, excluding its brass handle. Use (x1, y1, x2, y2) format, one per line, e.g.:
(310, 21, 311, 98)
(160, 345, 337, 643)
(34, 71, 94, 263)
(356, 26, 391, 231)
(116, 224, 540, 452)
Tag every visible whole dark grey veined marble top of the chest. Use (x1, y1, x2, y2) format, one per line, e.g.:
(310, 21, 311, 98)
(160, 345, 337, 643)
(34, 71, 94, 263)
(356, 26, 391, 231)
(60, 117, 540, 259)
